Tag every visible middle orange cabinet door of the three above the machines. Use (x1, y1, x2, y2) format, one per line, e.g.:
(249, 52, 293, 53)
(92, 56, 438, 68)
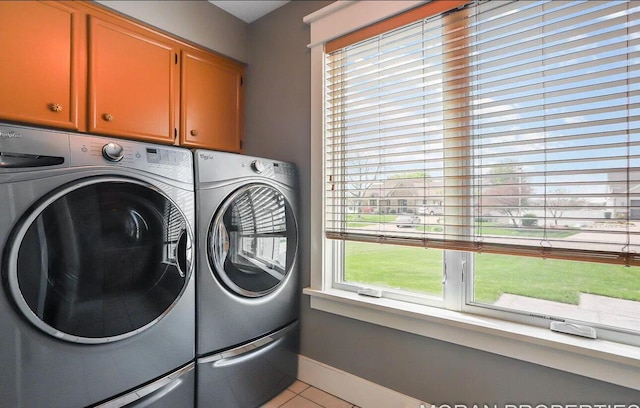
(89, 16, 178, 143)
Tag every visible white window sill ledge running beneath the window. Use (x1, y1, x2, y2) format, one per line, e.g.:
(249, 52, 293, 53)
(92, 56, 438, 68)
(304, 288, 640, 390)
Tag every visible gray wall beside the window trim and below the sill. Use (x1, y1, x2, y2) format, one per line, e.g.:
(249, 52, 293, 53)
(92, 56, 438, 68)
(245, 1, 640, 404)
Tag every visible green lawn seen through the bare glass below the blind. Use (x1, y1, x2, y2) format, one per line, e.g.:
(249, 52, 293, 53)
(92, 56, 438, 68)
(345, 242, 640, 304)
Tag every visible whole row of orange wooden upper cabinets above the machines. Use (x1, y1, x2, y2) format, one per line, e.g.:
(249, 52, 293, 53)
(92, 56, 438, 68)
(0, 0, 244, 152)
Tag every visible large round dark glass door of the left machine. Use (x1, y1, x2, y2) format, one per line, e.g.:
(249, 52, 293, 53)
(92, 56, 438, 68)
(6, 177, 193, 343)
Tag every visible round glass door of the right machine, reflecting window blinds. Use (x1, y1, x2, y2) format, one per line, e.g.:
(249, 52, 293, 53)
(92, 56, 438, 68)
(208, 183, 298, 298)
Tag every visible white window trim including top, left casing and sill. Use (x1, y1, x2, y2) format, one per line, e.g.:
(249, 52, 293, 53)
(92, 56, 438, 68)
(303, 0, 640, 390)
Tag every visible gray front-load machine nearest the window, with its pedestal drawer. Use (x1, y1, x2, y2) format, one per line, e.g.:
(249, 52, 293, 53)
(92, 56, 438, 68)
(194, 150, 300, 408)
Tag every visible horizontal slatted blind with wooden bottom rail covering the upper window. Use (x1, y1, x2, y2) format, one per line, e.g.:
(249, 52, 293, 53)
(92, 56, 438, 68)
(325, 1, 640, 265)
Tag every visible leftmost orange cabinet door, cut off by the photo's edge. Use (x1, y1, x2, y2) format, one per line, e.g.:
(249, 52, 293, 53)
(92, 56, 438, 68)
(0, 1, 84, 129)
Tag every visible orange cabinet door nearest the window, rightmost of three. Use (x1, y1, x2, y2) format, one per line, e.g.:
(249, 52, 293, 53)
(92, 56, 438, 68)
(180, 51, 244, 152)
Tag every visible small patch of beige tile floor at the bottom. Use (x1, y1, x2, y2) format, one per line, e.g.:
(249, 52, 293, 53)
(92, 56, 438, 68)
(260, 380, 358, 408)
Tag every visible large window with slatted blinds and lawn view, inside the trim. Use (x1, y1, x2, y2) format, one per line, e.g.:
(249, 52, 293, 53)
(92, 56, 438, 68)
(324, 1, 640, 342)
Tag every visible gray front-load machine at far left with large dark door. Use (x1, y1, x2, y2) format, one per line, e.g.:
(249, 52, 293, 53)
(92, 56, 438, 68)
(0, 124, 195, 408)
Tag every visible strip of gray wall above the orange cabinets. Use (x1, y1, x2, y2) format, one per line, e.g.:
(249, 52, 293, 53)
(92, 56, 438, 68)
(96, 0, 248, 62)
